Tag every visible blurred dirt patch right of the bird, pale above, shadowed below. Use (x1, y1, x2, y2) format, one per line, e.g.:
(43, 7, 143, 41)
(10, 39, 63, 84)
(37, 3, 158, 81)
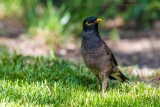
(106, 38, 160, 68)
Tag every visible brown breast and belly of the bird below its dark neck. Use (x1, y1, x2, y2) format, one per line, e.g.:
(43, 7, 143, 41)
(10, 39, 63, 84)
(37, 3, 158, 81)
(81, 40, 112, 75)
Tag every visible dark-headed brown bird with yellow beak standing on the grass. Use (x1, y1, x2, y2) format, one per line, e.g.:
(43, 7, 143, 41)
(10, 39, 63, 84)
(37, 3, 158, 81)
(81, 16, 130, 95)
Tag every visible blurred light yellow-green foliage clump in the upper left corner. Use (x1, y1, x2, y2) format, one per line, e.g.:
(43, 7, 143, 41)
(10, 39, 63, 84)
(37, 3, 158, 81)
(0, 0, 63, 38)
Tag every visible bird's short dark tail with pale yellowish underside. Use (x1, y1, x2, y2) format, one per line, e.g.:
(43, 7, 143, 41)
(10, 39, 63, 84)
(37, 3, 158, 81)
(109, 71, 130, 83)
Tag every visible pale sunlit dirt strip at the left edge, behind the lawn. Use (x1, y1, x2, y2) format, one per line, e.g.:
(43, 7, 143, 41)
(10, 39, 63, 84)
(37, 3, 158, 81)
(0, 36, 49, 56)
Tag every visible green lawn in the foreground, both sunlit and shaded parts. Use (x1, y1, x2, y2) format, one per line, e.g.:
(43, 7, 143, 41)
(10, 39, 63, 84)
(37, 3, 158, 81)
(0, 47, 160, 107)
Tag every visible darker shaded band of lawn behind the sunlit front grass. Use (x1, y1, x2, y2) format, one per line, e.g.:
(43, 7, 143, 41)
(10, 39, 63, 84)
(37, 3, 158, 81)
(0, 47, 136, 91)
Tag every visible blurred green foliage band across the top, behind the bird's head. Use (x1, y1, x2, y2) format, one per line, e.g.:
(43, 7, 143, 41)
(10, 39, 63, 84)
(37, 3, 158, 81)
(0, 0, 160, 38)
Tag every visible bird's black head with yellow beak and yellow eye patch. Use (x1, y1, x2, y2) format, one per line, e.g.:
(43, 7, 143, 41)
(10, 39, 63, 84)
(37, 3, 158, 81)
(83, 16, 102, 31)
